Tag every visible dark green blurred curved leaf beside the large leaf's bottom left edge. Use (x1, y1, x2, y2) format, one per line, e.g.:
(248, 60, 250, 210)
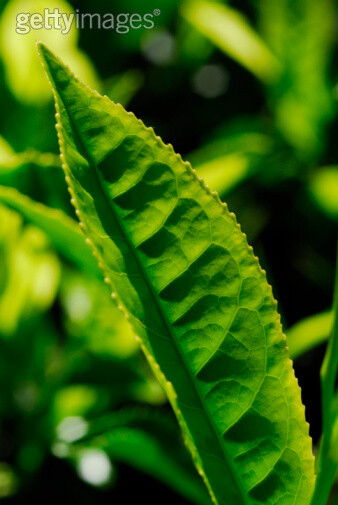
(62, 407, 210, 505)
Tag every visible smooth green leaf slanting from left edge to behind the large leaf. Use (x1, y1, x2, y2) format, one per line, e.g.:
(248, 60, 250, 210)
(0, 186, 101, 276)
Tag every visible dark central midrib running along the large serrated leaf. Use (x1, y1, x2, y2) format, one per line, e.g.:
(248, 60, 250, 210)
(61, 92, 250, 505)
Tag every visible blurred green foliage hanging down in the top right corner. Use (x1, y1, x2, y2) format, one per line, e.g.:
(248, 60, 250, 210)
(257, 0, 335, 159)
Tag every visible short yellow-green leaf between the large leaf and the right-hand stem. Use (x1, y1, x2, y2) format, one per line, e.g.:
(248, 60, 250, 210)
(286, 311, 332, 359)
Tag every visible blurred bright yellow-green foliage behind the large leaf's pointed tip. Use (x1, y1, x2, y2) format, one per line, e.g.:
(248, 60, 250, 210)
(0, 0, 100, 105)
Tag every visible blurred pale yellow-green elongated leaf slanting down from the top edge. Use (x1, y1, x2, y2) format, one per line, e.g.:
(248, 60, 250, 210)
(181, 0, 280, 82)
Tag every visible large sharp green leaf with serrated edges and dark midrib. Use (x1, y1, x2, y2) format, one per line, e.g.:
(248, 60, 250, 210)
(40, 45, 314, 505)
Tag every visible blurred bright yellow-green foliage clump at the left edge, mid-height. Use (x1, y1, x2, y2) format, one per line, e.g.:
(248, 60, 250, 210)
(0, 203, 60, 338)
